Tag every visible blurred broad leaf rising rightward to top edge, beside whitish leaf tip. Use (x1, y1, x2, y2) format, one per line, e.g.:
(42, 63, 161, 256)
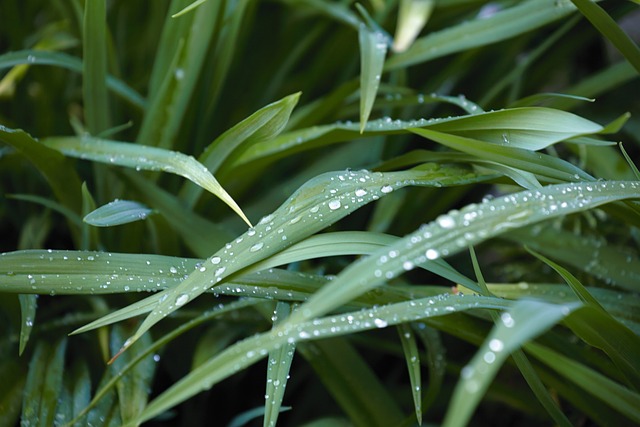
(386, 0, 575, 70)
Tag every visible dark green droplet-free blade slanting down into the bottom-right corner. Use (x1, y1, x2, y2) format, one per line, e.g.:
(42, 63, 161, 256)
(525, 343, 640, 423)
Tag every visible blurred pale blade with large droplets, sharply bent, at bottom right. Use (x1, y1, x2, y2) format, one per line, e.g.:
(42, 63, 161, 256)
(443, 300, 579, 426)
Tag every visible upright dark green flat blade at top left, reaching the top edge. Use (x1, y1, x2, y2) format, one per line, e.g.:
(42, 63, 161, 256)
(82, 0, 110, 135)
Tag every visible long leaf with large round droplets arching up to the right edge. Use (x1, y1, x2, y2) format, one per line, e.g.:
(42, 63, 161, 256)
(290, 182, 640, 323)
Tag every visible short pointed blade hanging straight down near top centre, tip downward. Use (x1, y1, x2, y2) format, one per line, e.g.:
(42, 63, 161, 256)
(358, 24, 388, 133)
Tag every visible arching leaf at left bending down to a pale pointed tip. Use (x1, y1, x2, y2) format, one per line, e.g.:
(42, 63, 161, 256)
(44, 137, 251, 229)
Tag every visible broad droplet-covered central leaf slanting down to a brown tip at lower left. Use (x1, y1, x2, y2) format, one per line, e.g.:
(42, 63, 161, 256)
(105, 165, 490, 358)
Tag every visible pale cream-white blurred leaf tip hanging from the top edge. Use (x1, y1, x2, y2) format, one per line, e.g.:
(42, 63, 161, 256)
(393, 0, 435, 52)
